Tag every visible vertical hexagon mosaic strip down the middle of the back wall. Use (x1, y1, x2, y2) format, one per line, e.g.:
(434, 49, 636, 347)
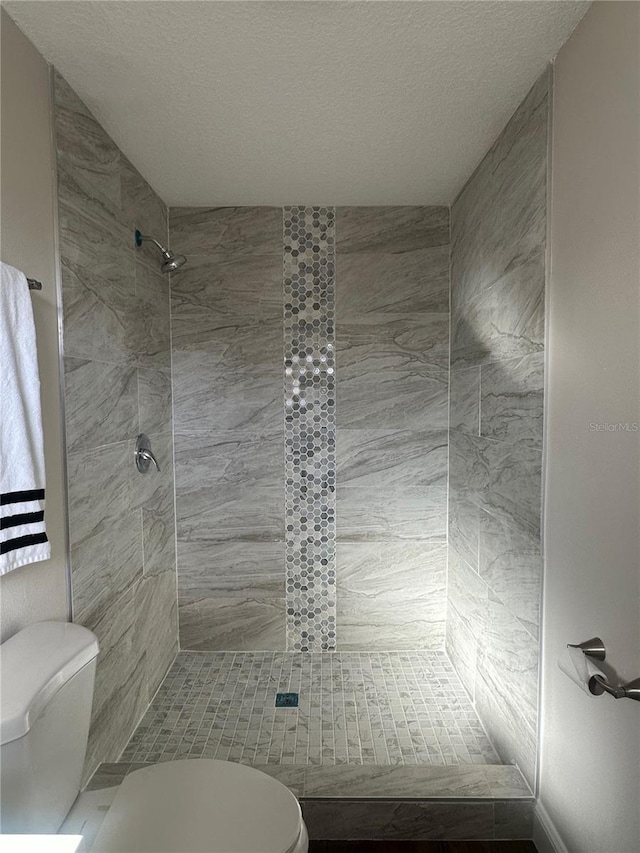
(283, 207, 336, 651)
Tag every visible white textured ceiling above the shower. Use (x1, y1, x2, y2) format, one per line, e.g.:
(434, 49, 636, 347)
(4, 0, 589, 205)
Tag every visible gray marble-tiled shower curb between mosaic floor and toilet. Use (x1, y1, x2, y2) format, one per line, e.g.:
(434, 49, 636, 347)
(85, 762, 535, 840)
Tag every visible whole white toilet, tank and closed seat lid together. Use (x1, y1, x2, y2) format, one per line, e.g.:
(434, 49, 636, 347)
(0, 622, 308, 853)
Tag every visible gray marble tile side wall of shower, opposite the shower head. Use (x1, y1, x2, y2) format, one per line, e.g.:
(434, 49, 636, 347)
(446, 73, 549, 784)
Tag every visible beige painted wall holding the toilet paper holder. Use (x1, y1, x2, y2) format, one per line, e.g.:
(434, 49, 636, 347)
(539, 2, 640, 853)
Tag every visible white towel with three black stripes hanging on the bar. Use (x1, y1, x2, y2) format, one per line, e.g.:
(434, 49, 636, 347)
(0, 263, 51, 575)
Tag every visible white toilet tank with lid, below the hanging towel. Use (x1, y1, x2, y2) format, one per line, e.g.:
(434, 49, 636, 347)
(0, 622, 98, 833)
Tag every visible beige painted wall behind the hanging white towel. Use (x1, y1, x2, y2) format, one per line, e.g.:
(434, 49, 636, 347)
(0, 9, 67, 640)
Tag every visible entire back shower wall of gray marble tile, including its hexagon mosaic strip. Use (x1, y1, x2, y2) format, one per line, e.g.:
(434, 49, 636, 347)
(170, 207, 449, 651)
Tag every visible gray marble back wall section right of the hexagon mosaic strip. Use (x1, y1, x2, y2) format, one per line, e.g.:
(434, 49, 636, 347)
(336, 207, 449, 650)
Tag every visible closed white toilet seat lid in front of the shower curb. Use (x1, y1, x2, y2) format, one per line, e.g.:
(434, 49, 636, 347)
(92, 759, 306, 853)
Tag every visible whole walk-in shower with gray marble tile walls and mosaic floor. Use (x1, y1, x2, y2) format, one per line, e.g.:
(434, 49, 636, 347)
(52, 61, 548, 837)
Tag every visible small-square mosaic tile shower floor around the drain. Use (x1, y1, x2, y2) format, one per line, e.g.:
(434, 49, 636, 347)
(120, 652, 501, 765)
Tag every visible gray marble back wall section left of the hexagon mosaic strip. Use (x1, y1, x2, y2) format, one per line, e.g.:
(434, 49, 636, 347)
(169, 207, 285, 651)
